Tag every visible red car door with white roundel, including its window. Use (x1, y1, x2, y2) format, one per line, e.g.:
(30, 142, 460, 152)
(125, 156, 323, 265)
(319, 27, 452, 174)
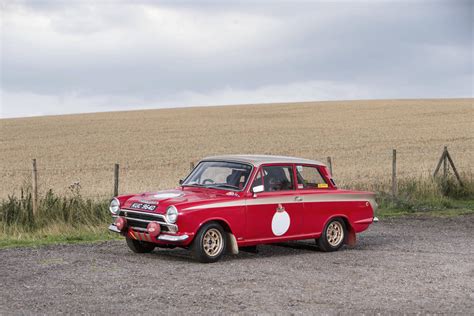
(245, 164, 303, 242)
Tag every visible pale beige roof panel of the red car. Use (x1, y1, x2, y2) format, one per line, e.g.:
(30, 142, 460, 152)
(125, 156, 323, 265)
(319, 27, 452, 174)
(202, 155, 325, 167)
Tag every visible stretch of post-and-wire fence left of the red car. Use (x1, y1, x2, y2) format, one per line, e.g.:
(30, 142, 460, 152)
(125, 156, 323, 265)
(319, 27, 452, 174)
(0, 164, 193, 199)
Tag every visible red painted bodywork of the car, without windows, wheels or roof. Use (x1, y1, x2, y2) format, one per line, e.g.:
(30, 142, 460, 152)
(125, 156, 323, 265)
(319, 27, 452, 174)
(111, 157, 374, 251)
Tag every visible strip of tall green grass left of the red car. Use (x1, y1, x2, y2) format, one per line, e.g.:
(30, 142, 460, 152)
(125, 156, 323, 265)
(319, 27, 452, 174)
(0, 188, 120, 248)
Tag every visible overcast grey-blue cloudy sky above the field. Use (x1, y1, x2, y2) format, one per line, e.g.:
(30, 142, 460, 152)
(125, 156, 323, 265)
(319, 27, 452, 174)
(0, 0, 474, 117)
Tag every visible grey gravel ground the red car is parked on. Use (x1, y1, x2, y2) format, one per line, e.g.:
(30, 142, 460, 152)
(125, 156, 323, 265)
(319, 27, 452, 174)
(0, 216, 474, 315)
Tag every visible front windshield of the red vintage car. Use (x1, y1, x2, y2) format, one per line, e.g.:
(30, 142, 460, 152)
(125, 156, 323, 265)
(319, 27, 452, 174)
(182, 161, 252, 191)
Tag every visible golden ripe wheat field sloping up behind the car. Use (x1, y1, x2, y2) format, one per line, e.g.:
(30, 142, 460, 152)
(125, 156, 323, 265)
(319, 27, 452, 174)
(0, 99, 474, 198)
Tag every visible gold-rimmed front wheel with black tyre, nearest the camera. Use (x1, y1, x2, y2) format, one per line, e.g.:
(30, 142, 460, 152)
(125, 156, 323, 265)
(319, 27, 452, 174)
(191, 222, 227, 263)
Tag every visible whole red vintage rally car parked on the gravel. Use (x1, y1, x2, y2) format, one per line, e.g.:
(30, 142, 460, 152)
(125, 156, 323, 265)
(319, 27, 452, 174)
(109, 155, 377, 262)
